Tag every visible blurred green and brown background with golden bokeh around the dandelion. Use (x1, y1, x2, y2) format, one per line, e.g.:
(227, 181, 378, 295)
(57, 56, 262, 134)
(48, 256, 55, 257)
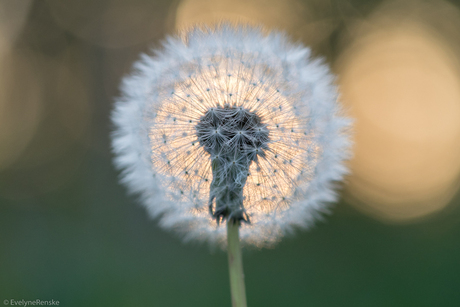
(0, 0, 460, 307)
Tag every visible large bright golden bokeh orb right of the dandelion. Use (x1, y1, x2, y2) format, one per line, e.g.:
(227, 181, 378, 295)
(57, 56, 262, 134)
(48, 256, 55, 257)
(338, 1, 460, 221)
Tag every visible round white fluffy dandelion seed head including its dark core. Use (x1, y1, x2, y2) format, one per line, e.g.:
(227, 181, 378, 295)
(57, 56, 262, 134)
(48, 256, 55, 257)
(112, 24, 350, 246)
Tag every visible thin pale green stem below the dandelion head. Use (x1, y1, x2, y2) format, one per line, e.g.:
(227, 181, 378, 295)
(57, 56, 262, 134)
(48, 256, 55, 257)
(227, 219, 247, 307)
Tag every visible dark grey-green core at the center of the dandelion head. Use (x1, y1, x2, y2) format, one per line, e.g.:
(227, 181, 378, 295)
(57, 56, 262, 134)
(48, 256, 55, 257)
(195, 106, 269, 224)
